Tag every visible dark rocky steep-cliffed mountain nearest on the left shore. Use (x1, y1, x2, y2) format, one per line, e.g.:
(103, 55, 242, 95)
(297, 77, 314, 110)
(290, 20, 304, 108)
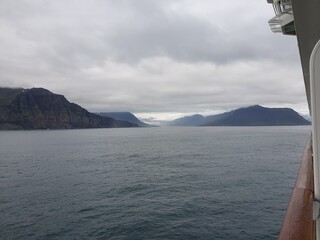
(0, 88, 138, 130)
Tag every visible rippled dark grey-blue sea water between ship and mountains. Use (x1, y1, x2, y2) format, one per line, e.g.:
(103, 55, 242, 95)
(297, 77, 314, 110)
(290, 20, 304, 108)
(0, 127, 310, 240)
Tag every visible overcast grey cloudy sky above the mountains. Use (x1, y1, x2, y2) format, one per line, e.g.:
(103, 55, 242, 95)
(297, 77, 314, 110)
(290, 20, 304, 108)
(0, 0, 308, 122)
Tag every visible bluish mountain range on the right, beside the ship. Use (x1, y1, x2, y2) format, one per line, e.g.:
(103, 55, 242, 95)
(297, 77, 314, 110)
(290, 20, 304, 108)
(167, 105, 310, 126)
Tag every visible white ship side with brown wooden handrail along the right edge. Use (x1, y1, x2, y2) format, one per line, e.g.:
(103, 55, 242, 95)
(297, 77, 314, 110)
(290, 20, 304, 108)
(267, 0, 320, 240)
